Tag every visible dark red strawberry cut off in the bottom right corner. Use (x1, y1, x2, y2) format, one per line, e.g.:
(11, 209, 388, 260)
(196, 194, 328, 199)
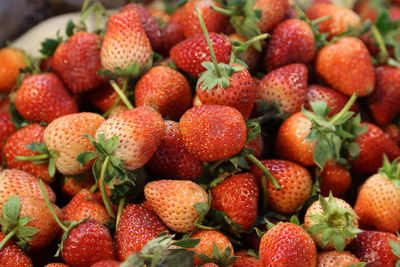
(348, 231, 399, 267)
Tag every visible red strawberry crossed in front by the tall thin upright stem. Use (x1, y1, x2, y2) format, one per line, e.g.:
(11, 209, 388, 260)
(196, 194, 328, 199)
(170, 33, 232, 78)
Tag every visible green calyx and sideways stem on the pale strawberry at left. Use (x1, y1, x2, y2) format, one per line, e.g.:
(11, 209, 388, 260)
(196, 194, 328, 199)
(15, 143, 57, 177)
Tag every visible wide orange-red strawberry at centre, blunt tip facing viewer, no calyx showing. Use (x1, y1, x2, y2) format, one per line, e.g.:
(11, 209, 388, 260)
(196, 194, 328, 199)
(179, 105, 247, 162)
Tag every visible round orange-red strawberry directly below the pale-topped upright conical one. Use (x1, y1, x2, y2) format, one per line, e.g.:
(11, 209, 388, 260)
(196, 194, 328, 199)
(135, 66, 192, 120)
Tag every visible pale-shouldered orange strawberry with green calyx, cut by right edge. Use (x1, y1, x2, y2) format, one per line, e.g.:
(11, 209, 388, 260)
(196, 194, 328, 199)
(354, 157, 400, 233)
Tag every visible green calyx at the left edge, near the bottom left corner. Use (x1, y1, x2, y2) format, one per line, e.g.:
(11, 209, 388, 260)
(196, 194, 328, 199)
(0, 195, 38, 250)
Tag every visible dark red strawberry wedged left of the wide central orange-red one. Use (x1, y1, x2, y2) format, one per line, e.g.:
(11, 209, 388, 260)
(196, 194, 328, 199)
(147, 120, 204, 180)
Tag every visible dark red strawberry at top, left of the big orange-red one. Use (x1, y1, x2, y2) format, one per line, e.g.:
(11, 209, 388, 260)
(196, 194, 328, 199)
(264, 19, 316, 71)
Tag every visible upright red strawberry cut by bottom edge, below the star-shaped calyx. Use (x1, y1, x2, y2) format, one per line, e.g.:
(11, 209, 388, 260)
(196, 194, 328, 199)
(260, 223, 317, 267)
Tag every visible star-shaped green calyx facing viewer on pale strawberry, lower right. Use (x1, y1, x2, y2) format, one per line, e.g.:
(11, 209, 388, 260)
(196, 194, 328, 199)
(308, 193, 362, 251)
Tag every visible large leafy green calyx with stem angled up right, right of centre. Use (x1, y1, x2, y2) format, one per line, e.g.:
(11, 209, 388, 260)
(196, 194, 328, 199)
(302, 93, 367, 169)
